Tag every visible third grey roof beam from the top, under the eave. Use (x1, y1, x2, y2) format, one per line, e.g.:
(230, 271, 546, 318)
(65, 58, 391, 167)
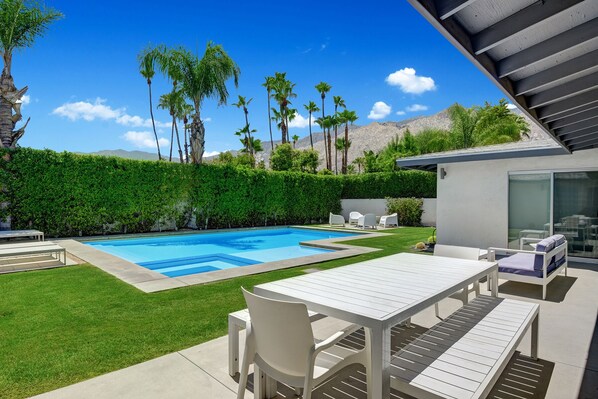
(496, 19, 598, 78)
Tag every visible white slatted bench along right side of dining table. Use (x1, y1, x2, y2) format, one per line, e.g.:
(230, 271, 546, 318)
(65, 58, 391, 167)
(391, 296, 539, 399)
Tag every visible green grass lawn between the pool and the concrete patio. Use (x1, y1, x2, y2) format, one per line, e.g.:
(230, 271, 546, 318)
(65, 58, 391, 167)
(0, 228, 432, 398)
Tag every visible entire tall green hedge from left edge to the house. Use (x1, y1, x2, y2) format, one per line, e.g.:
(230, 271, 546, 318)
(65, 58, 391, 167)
(0, 148, 436, 236)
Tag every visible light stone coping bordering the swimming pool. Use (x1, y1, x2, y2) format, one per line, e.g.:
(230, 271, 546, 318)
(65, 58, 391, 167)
(55, 226, 386, 293)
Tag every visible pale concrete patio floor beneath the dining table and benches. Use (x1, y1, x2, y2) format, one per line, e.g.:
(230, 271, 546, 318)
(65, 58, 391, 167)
(30, 263, 598, 399)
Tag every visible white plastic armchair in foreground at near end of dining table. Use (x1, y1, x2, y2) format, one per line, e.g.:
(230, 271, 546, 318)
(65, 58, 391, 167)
(237, 289, 368, 399)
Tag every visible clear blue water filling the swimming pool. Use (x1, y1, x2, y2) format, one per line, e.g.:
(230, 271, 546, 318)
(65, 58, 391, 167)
(87, 227, 355, 277)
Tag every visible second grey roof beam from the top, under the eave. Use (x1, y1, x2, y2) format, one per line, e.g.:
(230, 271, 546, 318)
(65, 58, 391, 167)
(471, 0, 583, 55)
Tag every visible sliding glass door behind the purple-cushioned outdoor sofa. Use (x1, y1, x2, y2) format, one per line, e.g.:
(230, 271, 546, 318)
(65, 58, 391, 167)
(508, 171, 598, 259)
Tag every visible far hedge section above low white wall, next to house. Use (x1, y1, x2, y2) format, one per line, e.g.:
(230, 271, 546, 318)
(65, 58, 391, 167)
(342, 170, 436, 198)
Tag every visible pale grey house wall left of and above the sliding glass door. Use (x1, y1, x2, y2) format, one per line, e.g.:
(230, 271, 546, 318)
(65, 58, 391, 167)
(436, 149, 598, 248)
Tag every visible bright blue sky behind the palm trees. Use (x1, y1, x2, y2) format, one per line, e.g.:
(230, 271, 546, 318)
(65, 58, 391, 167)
(13, 0, 503, 152)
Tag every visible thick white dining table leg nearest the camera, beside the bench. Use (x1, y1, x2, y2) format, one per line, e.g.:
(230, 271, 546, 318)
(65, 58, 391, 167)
(365, 327, 390, 399)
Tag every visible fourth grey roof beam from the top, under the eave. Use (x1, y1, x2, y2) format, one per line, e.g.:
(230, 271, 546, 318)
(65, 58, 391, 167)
(514, 50, 598, 96)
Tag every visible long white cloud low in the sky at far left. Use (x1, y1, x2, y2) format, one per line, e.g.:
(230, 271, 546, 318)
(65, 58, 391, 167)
(52, 97, 171, 128)
